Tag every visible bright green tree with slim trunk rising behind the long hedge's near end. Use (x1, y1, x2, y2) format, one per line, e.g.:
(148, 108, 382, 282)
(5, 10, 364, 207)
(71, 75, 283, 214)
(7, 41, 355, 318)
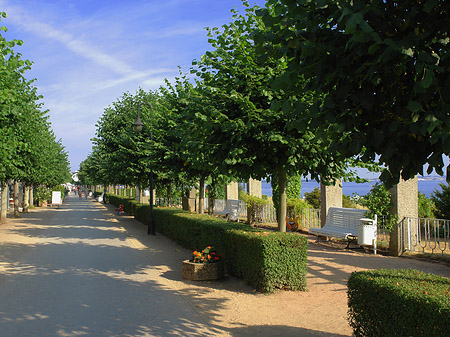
(193, 1, 354, 231)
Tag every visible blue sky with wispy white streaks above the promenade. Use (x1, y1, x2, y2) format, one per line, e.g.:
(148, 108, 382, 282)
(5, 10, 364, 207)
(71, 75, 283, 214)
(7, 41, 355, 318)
(0, 0, 265, 171)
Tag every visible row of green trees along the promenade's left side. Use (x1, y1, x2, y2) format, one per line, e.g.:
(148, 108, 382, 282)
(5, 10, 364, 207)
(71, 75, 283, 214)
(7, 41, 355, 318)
(0, 12, 71, 222)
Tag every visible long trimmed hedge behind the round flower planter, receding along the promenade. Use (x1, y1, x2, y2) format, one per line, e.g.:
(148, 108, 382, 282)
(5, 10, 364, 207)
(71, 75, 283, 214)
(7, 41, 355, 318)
(109, 196, 308, 292)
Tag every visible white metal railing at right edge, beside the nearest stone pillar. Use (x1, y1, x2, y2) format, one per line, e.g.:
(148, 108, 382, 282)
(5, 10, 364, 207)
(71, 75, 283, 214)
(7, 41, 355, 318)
(399, 217, 450, 255)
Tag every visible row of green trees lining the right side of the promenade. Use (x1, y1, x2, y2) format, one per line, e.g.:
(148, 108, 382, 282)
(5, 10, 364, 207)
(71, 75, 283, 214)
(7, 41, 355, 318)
(81, 0, 450, 231)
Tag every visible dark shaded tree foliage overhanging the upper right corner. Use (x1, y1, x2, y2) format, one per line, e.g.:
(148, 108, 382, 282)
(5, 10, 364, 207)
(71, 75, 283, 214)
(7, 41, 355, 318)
(255, 0, 450, 185)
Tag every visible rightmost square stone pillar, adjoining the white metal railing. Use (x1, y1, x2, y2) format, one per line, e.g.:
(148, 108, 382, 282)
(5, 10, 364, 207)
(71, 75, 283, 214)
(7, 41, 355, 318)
(389, 176, 419, 256)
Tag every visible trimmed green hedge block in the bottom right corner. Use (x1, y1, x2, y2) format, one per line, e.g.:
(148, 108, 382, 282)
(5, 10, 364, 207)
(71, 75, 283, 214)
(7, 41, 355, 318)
(347, 269, 450, 337)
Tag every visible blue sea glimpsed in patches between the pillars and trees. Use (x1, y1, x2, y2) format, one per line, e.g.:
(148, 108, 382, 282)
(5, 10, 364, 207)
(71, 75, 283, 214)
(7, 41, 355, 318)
(262, 177, 447, 198)
